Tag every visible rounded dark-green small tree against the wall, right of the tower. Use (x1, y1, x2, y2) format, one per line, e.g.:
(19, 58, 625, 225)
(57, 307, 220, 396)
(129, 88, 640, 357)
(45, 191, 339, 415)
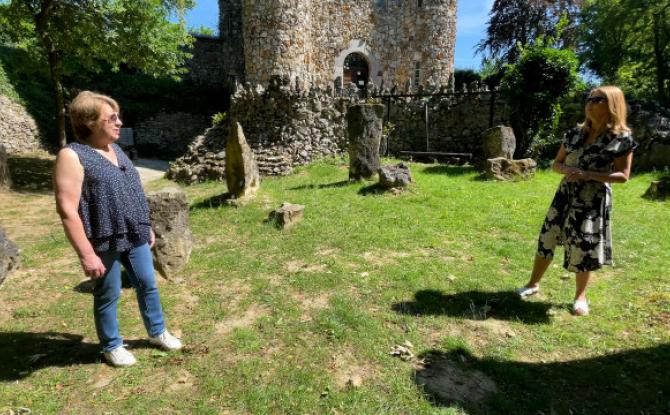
(502, 38, 579, 157)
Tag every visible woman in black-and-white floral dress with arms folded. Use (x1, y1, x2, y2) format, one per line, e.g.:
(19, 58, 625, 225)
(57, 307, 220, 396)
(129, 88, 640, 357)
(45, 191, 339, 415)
(516, 86, 637, 316)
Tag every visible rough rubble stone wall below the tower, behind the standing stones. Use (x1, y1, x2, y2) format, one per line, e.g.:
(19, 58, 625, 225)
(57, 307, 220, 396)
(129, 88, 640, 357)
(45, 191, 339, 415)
(169, 79, 505, 183)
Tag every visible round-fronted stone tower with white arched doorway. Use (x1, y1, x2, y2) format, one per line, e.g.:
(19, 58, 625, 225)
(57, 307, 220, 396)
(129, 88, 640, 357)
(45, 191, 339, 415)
(219, 0, 457, 87)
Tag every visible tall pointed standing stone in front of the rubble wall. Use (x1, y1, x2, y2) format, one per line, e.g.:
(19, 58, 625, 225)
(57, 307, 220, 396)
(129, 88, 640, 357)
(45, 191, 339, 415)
(226, 122, 261, 199)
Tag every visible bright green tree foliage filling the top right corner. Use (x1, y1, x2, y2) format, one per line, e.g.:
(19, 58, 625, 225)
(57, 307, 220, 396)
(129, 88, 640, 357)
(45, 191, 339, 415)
(579, 0, 670, 105)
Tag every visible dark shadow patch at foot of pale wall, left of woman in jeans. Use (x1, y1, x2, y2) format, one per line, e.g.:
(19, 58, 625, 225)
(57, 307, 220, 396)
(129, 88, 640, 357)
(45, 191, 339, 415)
(7, 155, 55, 193)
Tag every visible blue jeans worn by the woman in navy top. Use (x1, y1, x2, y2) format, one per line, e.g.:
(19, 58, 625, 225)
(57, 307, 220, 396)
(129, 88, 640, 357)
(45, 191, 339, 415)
(93, 244, 165, 352)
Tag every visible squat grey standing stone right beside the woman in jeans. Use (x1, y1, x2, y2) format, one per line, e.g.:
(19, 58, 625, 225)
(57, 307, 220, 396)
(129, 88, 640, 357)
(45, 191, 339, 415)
(147, 188, 193, 279)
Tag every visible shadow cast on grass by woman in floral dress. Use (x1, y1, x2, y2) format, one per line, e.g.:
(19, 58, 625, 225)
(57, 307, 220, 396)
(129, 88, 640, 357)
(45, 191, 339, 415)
(391, 290, 551, 324)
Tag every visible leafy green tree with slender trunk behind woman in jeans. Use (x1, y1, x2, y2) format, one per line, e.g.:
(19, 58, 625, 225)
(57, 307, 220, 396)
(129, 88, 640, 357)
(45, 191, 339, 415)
(0, 0, 193, 146)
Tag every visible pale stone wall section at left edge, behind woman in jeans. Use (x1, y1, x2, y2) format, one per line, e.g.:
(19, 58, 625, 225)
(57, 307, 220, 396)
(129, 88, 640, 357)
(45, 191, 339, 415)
(0, 95, 42, 154)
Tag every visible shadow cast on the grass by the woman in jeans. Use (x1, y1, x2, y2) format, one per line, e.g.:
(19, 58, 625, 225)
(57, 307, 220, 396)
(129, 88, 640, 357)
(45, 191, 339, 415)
(0, 332, 153, 382)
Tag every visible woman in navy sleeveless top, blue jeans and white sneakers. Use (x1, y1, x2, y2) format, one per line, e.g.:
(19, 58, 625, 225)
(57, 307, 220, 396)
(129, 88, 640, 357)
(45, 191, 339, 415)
(54, 91, 182, 366)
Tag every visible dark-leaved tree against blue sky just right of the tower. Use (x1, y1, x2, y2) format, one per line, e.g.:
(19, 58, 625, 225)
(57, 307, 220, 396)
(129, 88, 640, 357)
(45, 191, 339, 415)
(477, 0, 583, 63)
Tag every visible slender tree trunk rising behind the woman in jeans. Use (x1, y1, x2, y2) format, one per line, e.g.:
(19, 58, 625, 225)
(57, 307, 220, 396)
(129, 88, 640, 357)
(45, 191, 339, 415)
(34, 0, 67, 147)
